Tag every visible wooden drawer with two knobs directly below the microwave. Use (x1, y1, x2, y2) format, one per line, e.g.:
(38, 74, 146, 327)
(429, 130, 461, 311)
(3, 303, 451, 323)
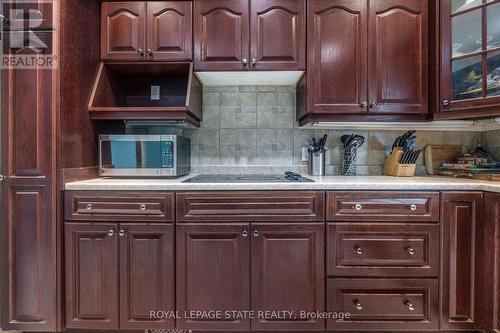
(64, 191, 175, 222)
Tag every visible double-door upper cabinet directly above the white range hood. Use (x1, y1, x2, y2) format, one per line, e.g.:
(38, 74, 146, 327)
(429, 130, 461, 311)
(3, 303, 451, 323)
(194, 0, 306, 71)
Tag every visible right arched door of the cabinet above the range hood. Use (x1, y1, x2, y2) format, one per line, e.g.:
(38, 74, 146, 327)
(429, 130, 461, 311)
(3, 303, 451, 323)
(250, 0, 306, 70)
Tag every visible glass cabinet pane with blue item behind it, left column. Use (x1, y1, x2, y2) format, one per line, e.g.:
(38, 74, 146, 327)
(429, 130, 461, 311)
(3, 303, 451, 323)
(451, 56, 483, 100)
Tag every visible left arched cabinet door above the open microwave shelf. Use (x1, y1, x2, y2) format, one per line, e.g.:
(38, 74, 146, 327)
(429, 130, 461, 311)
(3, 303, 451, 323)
(101, 2, 146, 60)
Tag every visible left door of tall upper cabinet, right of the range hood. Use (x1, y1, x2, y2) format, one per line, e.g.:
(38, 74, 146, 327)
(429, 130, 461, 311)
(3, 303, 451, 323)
(307, 0, 368, 113)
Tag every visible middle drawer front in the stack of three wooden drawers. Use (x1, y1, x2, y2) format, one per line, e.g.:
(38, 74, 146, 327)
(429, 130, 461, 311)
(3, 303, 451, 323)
(327, 223, 439, 277)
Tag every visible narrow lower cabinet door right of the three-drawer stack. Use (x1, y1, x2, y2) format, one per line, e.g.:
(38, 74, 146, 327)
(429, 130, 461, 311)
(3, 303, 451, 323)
(441, 192, 483, 330)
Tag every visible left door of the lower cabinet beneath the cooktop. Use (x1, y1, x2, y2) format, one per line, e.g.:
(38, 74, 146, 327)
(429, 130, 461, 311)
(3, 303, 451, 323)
(176, 224, 254, 331)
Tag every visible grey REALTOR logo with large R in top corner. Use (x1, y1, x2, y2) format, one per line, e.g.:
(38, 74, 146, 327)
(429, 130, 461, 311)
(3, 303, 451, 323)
(1, 0, 57, 69)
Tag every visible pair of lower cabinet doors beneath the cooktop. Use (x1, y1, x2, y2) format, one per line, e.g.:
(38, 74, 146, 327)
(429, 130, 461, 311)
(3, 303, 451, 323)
(176, 223, 325, 331)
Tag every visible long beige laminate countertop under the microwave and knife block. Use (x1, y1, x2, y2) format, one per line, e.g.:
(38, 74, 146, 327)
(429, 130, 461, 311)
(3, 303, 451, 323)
(65, 174, 500, 193)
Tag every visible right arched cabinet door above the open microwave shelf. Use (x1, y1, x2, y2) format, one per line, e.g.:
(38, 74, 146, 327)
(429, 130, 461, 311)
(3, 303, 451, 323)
(147, 1, 193, 61)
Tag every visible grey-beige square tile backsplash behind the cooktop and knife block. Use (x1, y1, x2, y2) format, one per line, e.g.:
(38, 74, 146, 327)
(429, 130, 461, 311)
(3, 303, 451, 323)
(184, 86, 492, 175)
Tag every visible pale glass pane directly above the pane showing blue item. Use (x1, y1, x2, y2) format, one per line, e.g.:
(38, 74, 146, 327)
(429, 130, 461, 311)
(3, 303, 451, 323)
(451, 9, 483, 57)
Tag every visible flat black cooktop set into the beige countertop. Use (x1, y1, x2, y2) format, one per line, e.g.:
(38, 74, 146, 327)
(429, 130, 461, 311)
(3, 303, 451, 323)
(183, 174, 314, 183)
